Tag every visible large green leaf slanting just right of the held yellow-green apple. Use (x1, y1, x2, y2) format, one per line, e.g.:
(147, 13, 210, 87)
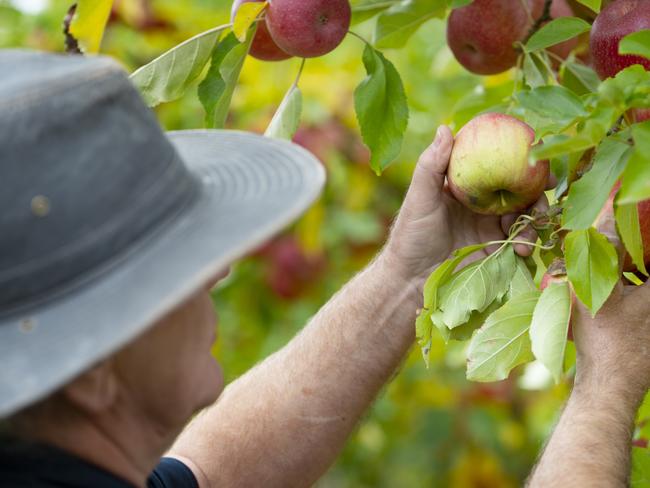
(562, 137, 631, 230)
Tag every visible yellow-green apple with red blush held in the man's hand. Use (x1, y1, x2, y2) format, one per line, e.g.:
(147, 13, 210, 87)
(447, 113, 549, 215)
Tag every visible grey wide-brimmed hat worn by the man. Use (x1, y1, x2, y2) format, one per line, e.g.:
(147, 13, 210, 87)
(0, 50, 325, 418)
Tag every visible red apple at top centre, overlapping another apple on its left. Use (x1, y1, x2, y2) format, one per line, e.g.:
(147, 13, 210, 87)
(266, 0, 352, 58)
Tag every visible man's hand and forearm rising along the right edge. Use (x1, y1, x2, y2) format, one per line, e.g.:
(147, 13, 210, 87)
(528, 233, 650, 488)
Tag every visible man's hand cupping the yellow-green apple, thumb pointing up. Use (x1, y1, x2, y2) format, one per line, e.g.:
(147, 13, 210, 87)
(383, 126, 548, 287)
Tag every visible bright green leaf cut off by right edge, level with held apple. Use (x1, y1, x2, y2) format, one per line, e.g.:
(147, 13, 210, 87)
(618, 120, 650, 203)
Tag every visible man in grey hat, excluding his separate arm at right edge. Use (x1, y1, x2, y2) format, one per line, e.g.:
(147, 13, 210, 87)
(0, 51, 644, 488)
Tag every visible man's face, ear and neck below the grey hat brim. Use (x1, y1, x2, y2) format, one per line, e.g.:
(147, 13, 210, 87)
(7, 271, 228, 444)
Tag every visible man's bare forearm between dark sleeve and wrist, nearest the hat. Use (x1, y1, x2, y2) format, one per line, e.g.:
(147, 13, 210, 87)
(173, 254, 421, 487)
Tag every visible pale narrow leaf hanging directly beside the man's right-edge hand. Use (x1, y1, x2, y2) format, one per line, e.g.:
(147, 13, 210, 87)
(530, 282, 571, 383)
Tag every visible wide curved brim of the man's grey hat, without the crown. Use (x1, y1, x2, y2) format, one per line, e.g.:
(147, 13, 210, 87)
(0, 130, 325, 417)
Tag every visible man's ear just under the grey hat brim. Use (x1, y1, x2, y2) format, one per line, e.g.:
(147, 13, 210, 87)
(63, 359, 118, 414)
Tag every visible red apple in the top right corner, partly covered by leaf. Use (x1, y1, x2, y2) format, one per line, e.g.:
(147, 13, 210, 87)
(589, 0, 650, 80)
